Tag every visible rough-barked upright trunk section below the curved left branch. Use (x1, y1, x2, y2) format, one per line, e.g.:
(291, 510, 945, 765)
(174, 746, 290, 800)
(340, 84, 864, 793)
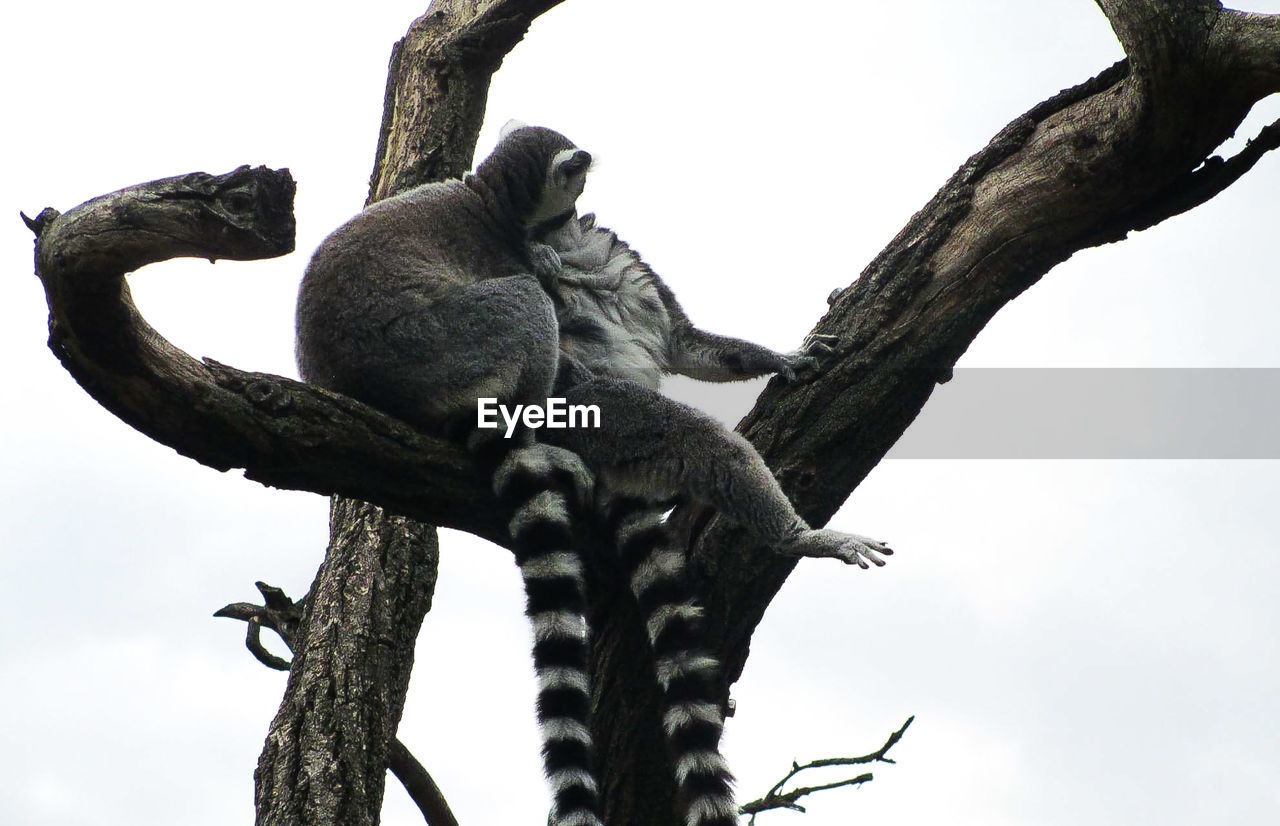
(255, 498, 439, 825)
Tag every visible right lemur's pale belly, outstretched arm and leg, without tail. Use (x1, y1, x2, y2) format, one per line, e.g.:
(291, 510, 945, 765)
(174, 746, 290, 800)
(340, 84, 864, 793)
(539, 215, 892, 569)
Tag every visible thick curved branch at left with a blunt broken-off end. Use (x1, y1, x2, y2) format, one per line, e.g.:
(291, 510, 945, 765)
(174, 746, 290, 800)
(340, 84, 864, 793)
(28, 166, 506, 542)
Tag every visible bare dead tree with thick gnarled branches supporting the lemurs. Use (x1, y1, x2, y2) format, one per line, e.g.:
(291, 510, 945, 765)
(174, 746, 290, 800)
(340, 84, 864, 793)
(28, 0, 1280, 825)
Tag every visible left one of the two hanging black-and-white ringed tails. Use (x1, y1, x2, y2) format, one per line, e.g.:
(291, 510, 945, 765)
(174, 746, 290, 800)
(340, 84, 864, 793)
(486, 432, 600, 826)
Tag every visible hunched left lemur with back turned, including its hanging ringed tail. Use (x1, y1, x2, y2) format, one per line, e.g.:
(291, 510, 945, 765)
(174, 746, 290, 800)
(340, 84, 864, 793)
(297, 128, 600, 826)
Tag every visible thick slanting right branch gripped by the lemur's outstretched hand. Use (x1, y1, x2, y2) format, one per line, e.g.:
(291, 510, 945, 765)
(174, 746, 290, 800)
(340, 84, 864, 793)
(682, 0, 1276, 675)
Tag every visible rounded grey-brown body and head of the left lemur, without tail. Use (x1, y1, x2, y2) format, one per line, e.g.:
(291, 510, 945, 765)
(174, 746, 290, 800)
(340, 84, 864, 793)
(297, 128, 590, 429)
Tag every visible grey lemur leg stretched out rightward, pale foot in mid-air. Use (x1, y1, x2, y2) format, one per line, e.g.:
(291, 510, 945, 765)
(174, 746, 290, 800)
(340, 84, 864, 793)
(541, 377, 892, 567)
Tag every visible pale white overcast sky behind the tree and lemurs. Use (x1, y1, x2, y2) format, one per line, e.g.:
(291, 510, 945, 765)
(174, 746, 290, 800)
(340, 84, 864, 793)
(0, 0, 1280, 826)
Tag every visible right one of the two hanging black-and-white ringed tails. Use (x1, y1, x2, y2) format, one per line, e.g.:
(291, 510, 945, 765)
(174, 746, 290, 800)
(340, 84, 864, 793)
(608, 498, 737, 826)
